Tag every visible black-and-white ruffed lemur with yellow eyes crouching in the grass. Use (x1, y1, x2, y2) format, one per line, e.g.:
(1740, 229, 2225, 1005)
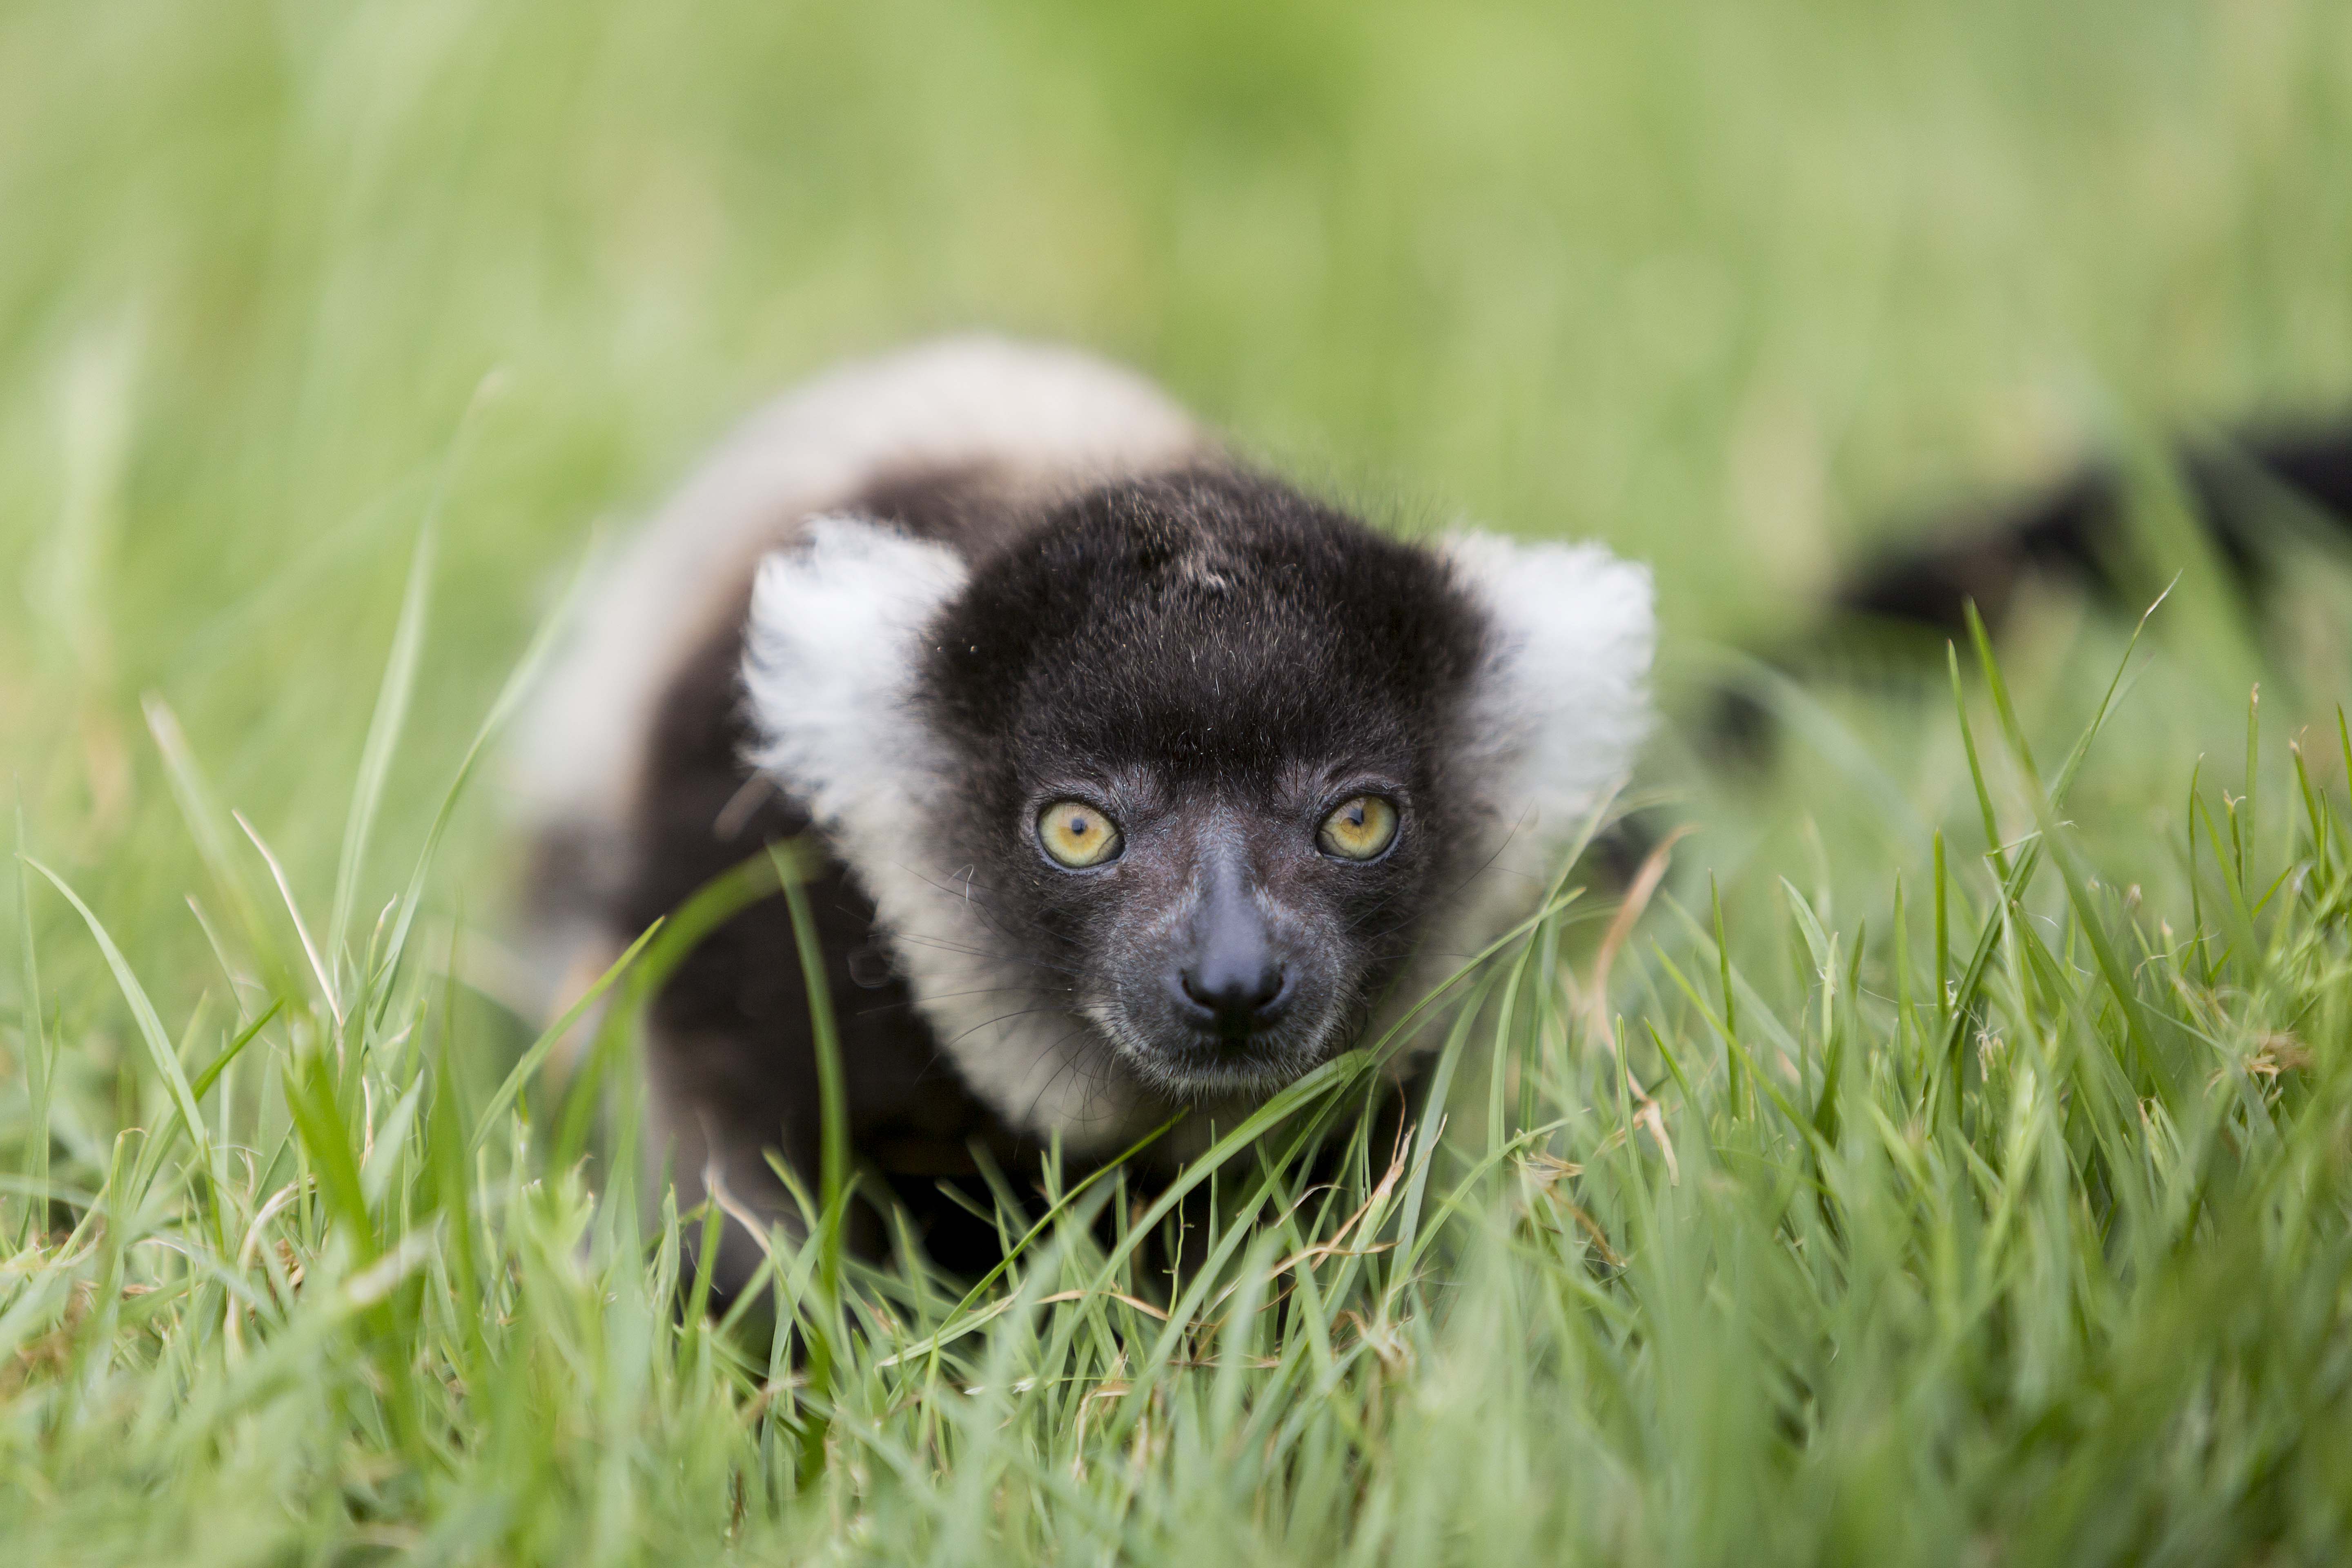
(513, 339, 2352, 1293)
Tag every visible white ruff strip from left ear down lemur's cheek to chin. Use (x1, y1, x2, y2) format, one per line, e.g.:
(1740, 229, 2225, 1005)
(743, 517, 1145, 1154)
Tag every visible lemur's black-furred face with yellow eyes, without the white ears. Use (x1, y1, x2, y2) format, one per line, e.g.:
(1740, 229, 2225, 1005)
(924, 477, 1479, 1096)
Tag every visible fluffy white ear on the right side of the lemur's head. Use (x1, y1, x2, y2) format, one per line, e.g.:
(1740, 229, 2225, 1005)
(1442, 534, 1658, 844)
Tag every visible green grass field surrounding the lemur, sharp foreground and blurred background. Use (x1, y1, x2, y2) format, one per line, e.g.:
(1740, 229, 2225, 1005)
(0, 0, 2352, 1566)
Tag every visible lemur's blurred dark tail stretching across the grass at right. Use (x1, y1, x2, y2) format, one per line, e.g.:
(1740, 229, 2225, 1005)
(1703, 419, 2352, 760)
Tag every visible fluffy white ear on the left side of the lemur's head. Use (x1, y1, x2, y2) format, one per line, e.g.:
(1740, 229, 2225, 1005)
(743, 517, 967, 856)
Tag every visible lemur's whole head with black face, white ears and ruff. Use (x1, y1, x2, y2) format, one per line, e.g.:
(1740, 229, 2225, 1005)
(748, 470, 1649, 1128)
